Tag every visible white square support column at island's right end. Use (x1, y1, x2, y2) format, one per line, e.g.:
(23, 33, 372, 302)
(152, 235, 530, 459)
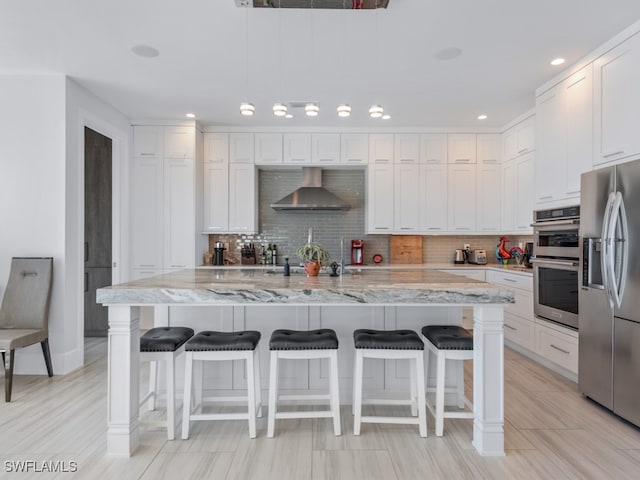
(473, 305, 504, 456)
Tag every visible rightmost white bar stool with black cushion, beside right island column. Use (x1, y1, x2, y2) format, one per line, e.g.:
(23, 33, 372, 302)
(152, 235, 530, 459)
(422, 325, 473, 437)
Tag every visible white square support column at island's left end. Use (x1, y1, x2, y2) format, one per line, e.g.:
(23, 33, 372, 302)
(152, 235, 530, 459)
(107, 305, 140, 457)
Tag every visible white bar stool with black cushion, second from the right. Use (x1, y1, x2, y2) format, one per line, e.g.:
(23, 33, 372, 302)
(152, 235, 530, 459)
(353, 329, 427, 437)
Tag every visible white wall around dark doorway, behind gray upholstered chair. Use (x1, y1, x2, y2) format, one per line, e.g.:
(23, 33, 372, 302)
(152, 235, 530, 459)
(0, 75, 130, 374)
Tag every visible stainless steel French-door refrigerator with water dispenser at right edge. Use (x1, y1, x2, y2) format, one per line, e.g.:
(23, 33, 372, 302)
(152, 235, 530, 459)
(578, 161, 640, 426)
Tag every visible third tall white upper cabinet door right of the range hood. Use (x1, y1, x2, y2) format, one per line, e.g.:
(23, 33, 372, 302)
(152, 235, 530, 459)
(420, 163, 448, 233)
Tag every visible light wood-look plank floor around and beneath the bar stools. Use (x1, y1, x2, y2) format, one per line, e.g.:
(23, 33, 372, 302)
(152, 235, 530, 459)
(0, 340, 640, 480)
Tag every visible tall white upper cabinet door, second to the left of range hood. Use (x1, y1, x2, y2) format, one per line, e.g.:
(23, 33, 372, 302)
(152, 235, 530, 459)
(203, 162, 229, 233)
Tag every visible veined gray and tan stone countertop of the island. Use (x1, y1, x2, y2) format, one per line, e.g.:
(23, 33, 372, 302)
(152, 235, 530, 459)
(97, 266, 514, 305)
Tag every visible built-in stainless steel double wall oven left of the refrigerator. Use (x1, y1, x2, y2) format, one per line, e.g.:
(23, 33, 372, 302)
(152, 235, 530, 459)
(531, 206, 580, 329)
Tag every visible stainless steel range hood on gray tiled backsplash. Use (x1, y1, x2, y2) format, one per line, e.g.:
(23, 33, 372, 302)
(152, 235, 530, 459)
(271, 167, 351, 210)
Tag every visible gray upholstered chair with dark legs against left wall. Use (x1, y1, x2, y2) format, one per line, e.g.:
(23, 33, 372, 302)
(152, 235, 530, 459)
(0, 257, 53, 402)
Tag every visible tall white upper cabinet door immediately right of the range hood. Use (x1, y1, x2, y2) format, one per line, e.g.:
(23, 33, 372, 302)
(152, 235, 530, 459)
(367, 163, 394, 233)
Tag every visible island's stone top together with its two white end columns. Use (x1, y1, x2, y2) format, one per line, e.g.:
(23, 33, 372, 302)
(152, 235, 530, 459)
(97, 268, 514, 456)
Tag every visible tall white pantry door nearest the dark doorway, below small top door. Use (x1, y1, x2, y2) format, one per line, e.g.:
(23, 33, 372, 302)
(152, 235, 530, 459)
(131, 158, 164, 269)
